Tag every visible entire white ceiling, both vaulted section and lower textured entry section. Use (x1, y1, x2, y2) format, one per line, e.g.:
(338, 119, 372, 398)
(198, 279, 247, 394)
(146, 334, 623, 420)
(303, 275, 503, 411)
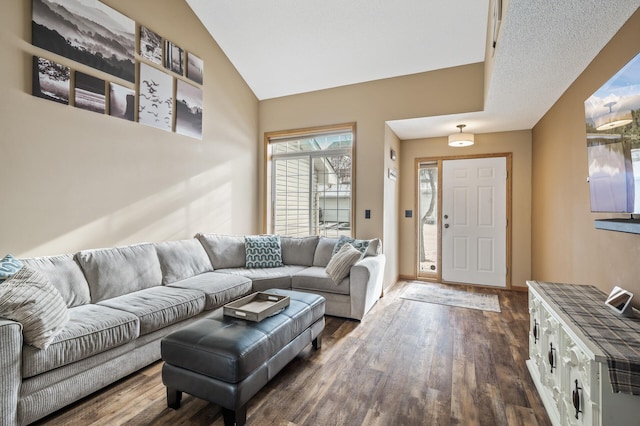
(187, 0, 640, 140)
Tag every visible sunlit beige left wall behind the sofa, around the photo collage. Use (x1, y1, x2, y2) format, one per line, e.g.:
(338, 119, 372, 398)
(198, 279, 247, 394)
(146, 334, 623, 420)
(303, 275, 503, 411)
(0, 0, 259, 256)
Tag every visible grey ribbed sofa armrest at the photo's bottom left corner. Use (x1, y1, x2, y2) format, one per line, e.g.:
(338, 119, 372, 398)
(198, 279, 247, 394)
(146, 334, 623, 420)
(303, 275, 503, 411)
(0, 318, 22, 425)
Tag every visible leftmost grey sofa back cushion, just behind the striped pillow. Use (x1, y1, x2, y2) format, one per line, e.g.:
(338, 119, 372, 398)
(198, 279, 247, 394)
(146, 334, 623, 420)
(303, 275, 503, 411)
(21, 254, 91, 308)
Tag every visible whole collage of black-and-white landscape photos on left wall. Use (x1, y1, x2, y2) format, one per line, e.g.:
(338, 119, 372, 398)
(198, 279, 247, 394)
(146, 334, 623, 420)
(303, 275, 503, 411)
(32, 0, 204, 139)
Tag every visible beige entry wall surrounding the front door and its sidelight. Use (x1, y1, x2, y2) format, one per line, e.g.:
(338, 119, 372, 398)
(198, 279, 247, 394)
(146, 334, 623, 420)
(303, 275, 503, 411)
(399, 130, 531, 287)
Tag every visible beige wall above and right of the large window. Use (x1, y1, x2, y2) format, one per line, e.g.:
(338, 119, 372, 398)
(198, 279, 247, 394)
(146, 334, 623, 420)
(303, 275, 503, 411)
(259, 63, 483, 286)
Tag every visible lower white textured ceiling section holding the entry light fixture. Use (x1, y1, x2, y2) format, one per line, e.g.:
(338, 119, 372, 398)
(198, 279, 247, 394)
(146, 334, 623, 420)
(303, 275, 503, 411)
(388, 0, 640, 140)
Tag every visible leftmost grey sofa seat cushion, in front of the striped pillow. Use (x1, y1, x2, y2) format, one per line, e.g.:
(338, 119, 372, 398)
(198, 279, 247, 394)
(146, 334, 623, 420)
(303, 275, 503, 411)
(22, 305, 140, 377)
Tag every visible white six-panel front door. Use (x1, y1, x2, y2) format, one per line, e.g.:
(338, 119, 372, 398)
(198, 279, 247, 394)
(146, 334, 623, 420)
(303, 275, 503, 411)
(441, 157, 507, 287)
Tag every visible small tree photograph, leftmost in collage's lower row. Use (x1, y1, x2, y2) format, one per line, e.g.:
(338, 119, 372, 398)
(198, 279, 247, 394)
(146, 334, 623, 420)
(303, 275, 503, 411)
(32, 56, 71, 105)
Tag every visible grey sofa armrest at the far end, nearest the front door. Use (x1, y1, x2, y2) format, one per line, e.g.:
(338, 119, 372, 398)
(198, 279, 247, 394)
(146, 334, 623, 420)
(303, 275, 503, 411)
(349, 254, 386, 320)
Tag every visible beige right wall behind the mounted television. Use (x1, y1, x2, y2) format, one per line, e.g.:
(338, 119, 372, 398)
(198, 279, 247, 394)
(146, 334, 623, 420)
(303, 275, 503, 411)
(532, 12, 640, 293)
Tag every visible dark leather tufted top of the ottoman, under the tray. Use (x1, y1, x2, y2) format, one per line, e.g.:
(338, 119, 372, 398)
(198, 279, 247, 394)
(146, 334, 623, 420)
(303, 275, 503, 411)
(161, 289, 325, 383)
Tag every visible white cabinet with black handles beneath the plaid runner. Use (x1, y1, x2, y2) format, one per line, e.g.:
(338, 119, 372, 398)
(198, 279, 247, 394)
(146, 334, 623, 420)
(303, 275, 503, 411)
(527, 281, 640, 426)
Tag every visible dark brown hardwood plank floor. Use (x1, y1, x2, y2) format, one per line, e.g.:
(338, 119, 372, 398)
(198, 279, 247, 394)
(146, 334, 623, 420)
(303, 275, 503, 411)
(39, 281, 550, 426)
